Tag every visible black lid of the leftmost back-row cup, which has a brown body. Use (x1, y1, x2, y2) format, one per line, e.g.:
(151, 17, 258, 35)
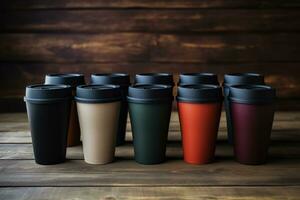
(45, 74, 85, 87)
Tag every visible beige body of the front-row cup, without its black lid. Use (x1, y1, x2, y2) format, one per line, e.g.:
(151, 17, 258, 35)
(77, 101, 121, 164)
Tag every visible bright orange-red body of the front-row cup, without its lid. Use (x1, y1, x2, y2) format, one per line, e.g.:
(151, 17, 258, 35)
(178, 102, 222, 164)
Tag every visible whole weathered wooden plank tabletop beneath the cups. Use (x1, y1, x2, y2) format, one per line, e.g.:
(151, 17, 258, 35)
(0, 112, 300, 200)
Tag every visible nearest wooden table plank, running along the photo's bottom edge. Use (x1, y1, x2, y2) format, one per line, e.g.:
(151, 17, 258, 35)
(0, 186, 300, 200)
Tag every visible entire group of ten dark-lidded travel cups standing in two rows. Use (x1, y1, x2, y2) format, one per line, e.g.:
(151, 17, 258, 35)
(24, 73, 275, 164)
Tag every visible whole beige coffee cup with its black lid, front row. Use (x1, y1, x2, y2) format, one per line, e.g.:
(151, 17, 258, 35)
(75, 85, 122, 164)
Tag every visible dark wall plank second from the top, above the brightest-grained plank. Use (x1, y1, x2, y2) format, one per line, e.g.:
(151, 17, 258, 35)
(0, 9, 300, 33)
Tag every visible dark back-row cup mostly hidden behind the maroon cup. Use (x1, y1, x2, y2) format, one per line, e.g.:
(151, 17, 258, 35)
(223, 73, 265, 144)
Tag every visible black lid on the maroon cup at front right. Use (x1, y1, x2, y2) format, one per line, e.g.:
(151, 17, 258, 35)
(229, 85, 276, 104)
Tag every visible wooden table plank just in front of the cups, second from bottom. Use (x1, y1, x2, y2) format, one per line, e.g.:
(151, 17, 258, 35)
(0, 157, 300, 187)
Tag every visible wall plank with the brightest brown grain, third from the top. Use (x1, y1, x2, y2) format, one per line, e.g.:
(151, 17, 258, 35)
(0, 33, 300, 64)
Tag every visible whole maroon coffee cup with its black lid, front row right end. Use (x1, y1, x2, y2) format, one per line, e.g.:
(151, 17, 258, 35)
(229, 85, 276, 165)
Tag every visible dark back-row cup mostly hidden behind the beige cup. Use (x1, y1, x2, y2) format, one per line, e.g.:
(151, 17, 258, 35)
(91, 73, 130, 145)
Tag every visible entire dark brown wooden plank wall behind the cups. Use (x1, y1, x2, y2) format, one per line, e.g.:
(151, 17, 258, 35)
(0, 0, 300, 111)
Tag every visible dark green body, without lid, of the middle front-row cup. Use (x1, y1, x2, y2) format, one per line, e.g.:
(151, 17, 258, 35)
(129, 101, 172, 164)
